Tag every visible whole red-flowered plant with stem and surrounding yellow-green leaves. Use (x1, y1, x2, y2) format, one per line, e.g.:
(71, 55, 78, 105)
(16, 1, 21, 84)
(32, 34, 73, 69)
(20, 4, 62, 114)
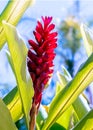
(0, 2, 93, 130)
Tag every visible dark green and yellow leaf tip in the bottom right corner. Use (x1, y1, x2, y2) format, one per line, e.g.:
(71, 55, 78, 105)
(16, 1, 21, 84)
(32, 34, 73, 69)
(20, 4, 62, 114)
(72, 110, 93, 130)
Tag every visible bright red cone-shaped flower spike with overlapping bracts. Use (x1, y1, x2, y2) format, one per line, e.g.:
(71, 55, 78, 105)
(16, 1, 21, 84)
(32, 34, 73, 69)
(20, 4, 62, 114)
(27, 17, 57, 106)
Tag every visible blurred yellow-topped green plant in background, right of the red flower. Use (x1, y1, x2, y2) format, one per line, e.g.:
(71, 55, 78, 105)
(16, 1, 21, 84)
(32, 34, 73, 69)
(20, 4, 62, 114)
(58, 17, 81, 76)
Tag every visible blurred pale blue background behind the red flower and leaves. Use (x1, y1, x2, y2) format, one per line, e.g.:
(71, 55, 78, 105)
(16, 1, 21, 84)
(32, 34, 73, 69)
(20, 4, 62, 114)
(0, 0, 93, 108)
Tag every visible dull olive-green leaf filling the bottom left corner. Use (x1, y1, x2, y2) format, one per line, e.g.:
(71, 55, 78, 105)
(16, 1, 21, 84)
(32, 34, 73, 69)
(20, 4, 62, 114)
(0, 99, 17, 130)
